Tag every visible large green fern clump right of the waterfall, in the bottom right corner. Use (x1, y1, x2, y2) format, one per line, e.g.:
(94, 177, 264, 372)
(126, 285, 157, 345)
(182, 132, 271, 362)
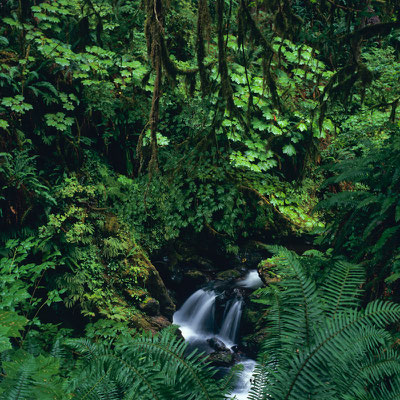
(249, 247, 400, 400)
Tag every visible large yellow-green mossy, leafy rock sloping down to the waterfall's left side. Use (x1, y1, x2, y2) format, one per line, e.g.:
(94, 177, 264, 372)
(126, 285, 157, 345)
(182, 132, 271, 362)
(42, 177, 175, 330)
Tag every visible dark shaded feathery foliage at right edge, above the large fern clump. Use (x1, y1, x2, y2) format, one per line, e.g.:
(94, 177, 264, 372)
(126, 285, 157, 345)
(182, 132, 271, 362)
(317, 127, 400, 300)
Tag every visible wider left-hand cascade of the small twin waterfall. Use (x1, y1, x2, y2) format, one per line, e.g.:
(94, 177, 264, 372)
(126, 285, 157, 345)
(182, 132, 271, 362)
(173, 289, 216, 339)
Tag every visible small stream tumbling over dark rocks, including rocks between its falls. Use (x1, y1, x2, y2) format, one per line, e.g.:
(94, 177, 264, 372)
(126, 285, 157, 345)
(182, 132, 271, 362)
(173, 270, 262, 400)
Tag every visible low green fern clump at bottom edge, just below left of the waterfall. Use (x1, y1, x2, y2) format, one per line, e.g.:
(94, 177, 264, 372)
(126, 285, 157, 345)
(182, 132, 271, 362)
(68, 330, 233, 400)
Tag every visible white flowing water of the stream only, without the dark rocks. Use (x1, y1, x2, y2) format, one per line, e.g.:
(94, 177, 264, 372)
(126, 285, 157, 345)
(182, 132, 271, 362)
(173, 286, 261, 400)
